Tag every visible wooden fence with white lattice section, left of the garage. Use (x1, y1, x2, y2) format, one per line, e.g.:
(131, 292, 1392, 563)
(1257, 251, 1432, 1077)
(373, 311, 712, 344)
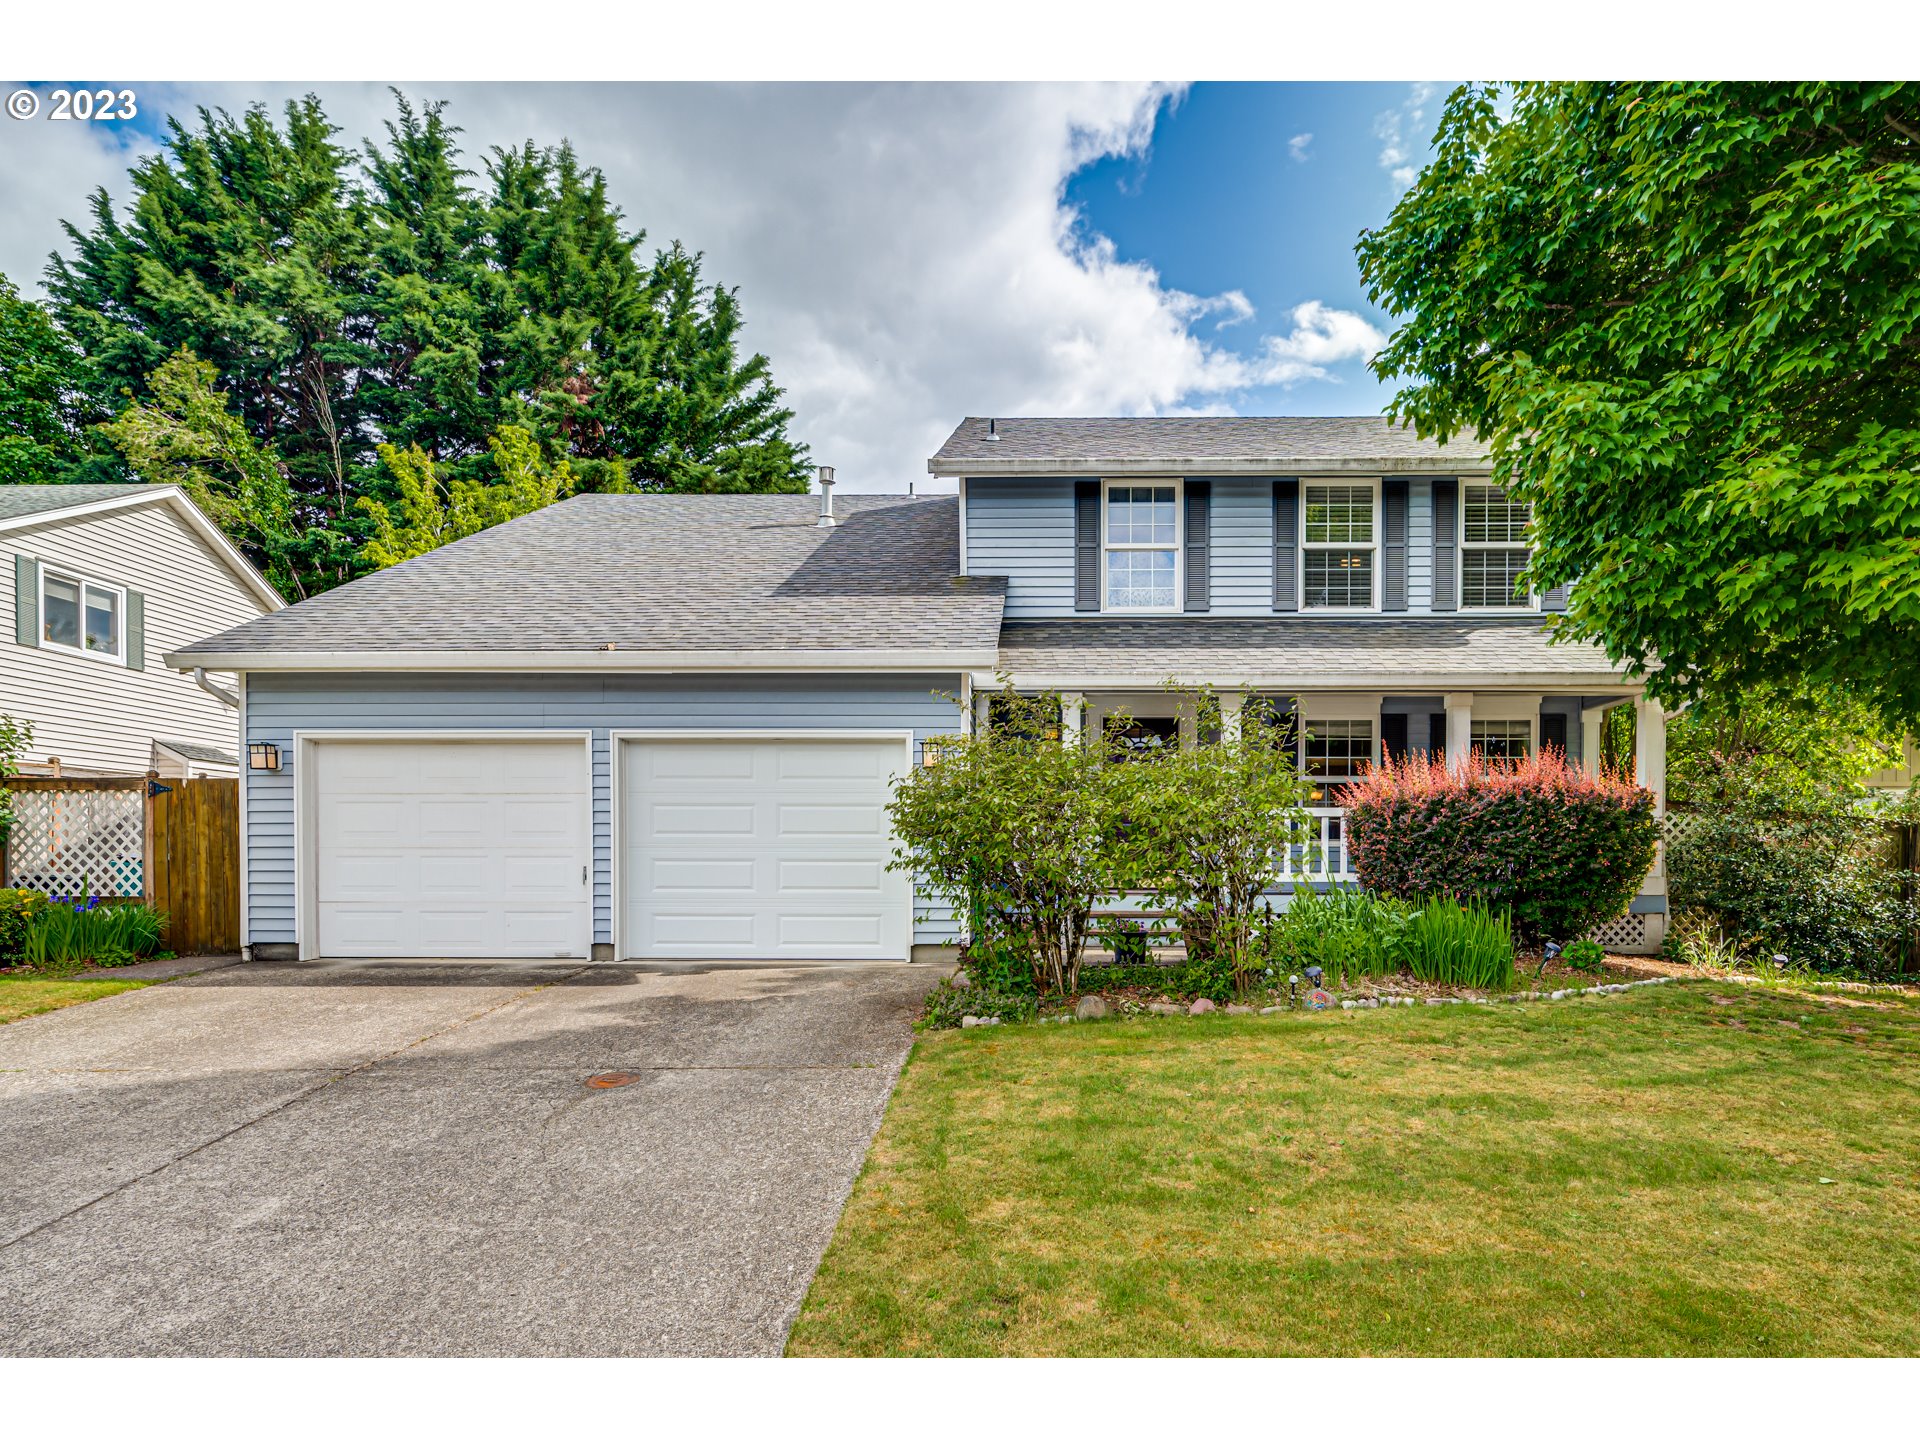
(0, 774, 240, 954)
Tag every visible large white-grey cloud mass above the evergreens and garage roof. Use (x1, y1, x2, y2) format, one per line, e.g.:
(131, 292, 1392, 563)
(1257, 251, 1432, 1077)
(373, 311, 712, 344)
(0, 83, 1379, 490)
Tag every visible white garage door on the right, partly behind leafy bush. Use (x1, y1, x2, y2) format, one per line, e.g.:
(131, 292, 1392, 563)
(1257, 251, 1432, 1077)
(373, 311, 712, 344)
(620, 737, 912, 960)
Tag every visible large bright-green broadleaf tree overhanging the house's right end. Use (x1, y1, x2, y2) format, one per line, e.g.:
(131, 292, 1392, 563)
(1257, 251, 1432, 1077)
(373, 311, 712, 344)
(1357, 83, 1920, 726)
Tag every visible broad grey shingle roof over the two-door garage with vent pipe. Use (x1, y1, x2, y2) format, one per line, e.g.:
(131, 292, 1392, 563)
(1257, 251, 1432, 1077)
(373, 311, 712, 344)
(179, 495, 1006, 662)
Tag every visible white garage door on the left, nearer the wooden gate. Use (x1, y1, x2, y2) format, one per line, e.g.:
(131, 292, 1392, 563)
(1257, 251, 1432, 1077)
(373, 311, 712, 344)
(307, 739, 593, 958)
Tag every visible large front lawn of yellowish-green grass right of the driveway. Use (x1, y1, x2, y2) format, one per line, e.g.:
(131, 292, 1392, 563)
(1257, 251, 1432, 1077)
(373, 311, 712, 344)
(789, 983, 1920, 1356)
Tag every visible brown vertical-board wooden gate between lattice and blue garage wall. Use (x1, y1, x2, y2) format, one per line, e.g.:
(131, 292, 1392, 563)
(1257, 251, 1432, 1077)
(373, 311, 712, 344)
(146, 780, 240, 954)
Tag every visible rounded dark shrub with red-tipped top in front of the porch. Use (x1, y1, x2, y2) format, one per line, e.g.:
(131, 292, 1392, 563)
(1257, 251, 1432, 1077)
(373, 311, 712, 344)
(1338, 751, 1655, 943)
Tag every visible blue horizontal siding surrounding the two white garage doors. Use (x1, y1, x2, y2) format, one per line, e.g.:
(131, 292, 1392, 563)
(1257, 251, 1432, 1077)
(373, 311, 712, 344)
(242, 672, 975, 960)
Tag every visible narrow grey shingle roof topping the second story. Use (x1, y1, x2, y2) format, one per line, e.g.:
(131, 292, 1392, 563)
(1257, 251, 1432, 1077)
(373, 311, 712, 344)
(927, 415, 1488, 474)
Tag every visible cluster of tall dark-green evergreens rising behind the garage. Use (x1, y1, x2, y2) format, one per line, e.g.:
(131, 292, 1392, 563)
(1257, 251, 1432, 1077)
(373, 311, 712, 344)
(48, 96, 806, 593)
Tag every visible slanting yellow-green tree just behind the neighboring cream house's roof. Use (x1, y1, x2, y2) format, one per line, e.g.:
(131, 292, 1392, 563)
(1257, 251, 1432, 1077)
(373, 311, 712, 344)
(100, 349, 311, 599)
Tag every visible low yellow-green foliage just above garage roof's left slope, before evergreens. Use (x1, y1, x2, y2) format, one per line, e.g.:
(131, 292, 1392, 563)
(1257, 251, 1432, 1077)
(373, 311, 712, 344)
(359, 424, 574, 568)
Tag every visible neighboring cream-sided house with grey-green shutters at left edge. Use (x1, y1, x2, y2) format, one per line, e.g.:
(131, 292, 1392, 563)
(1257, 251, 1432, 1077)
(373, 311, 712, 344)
(0, 486, 284, 776)
